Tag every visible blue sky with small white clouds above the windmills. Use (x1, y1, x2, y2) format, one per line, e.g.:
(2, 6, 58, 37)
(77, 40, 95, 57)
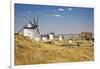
(15, 4, 94, 34)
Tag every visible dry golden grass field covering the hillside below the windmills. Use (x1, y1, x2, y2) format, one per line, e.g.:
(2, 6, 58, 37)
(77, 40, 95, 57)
(15, 34, 94, 65)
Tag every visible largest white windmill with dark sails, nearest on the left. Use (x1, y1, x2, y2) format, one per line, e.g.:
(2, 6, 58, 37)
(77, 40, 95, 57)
(18, 17, 40, 38)
